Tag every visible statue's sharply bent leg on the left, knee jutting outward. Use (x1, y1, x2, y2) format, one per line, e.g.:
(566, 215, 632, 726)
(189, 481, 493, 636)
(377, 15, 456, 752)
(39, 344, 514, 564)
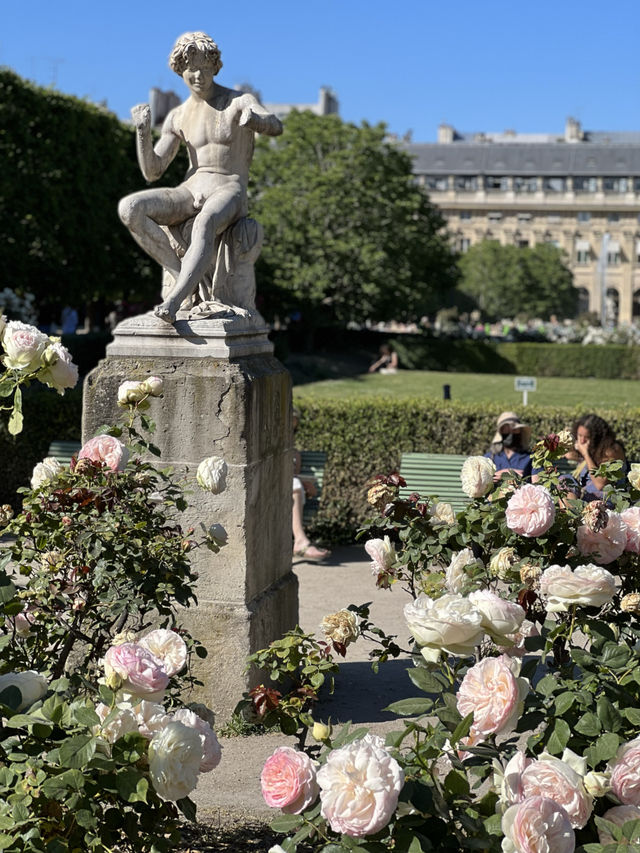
(118, 188, 194, 279)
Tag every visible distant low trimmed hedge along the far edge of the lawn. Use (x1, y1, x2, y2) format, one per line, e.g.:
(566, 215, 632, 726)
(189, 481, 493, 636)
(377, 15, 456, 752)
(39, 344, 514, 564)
(392, 335, 640, 379)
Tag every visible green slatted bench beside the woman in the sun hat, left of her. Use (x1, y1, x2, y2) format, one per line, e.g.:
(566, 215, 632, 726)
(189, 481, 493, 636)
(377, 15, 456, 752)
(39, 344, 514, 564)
(400, 453, 469, 512)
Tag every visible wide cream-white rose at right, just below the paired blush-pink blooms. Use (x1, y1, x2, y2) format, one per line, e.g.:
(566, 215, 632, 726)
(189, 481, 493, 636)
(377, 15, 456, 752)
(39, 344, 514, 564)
(540, 563, 616, 613)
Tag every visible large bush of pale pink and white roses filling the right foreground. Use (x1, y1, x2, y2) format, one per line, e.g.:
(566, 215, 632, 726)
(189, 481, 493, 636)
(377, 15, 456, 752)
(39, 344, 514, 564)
(260, 434, 640, 853)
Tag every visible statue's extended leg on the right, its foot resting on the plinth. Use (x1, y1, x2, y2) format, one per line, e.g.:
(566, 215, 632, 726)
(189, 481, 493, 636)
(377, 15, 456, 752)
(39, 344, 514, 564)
(154, 185, 244, 323)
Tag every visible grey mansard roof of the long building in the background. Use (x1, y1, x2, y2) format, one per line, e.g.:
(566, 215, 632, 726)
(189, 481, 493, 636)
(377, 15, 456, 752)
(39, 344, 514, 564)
(403, 141, 640, 176)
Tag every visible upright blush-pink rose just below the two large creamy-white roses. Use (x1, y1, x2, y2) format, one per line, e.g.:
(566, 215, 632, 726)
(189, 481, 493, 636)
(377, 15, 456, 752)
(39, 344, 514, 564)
(457, 655, 529, 739)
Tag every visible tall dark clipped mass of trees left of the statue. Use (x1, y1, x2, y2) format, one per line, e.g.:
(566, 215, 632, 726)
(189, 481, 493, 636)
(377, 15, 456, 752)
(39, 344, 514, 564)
(0, 69, 184, 305)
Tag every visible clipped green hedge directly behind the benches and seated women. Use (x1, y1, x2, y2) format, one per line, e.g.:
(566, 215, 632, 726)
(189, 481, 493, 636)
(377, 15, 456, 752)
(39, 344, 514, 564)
(296, 398, 640, 542)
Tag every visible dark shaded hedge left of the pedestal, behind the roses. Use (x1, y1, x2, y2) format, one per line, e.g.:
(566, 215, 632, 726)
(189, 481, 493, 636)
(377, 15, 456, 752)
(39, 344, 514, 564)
(0, 386, 82, 509)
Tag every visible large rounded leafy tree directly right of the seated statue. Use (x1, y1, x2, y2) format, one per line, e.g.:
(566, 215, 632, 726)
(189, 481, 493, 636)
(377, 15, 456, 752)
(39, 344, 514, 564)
(250, 112, 457, 336)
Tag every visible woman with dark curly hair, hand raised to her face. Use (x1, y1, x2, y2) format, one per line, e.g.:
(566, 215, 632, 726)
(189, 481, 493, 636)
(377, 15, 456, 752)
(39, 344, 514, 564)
(567, 414, 629, 501)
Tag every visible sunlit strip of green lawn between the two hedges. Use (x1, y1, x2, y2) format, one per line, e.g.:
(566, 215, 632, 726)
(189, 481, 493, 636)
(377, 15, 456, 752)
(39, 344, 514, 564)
(293, 370, 640, 411)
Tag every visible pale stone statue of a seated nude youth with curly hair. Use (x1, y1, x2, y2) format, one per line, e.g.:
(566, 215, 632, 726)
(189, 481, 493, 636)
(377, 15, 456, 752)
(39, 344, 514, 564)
(118, 32, 282, 323)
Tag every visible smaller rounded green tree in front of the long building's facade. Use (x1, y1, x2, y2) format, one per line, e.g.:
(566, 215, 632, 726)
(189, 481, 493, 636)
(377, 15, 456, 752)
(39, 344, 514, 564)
(459, 240, 577, 318)
